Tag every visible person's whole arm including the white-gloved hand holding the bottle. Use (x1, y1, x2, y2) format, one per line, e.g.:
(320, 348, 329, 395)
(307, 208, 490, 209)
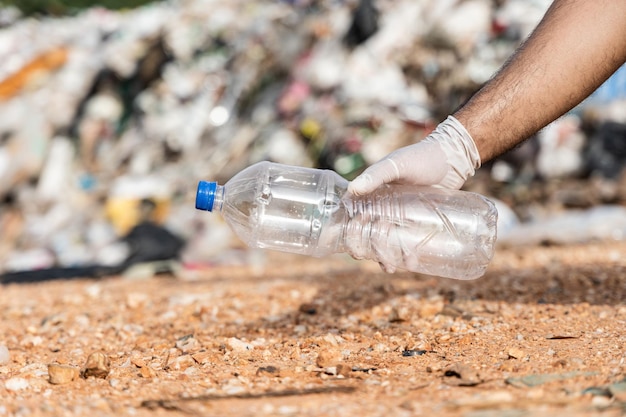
(350, 0, 626, 194)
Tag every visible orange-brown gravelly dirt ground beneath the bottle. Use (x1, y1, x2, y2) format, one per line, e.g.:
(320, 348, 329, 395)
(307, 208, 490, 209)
(0, 242, 626, 417)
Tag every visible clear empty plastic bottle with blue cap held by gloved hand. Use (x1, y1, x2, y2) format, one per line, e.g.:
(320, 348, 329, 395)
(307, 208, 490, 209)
(196, 162, 498, 279)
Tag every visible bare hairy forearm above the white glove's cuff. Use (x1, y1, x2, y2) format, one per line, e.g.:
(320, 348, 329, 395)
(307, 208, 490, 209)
(454, 0, 626, 161)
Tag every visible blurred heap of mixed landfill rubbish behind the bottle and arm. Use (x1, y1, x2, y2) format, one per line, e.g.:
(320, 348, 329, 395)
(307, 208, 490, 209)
(0, 0, 626, 280)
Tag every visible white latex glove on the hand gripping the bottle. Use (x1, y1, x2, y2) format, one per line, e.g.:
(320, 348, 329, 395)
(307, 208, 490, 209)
(348, 116, 480, 195)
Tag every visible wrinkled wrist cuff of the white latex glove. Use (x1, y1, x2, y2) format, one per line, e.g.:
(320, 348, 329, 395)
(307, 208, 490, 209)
(424, 116, 481, 189)
